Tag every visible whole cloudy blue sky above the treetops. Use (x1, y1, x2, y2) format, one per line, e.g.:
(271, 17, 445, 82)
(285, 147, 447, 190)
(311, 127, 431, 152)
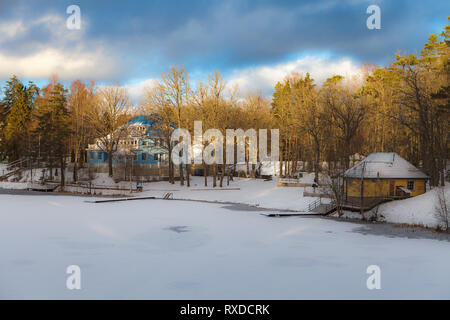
(0, 0, 450, 96)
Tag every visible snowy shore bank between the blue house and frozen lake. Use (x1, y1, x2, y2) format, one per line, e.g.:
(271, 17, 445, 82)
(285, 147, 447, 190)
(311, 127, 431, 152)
(0, 173, 317, 211)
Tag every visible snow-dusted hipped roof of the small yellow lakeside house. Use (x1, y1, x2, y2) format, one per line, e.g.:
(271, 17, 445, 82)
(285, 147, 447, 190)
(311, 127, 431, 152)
(344, 152, 428, 179)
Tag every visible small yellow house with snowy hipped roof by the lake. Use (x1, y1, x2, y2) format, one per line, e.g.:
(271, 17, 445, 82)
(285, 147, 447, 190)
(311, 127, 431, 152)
(344, 152, 428, 199)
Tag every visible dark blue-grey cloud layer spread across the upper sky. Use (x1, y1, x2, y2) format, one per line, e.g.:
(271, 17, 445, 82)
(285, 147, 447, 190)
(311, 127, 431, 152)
(0, 0, 450, 78)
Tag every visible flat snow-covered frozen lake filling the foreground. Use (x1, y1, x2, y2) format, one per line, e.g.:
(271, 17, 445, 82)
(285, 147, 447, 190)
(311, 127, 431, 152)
(0, 195, 450, 299)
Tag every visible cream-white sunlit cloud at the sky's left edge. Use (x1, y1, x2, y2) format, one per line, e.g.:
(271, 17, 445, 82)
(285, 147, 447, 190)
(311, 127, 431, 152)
(0, 14, 121, 80)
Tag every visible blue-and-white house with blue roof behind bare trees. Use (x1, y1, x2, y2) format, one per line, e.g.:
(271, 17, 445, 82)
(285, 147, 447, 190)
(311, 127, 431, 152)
(87, 116, 169, 165)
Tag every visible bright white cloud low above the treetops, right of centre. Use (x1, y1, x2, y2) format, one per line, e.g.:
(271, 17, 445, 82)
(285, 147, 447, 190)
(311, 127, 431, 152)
(227, 56, 361, 95)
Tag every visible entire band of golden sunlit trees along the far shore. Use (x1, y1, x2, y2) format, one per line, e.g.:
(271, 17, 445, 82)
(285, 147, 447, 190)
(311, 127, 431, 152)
(0, 20, 450, 186)
